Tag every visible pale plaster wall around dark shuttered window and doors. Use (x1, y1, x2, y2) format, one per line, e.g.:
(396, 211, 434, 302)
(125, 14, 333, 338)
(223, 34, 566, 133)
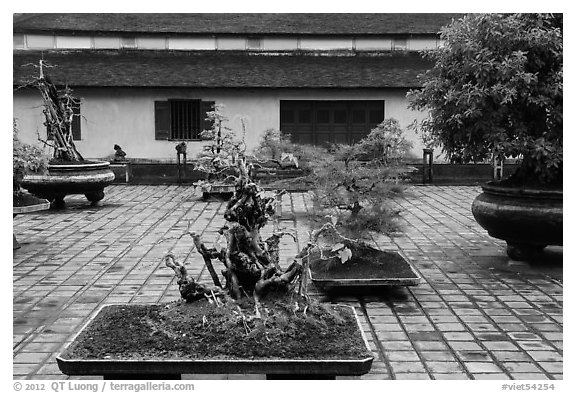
(14, 88, 422, 161)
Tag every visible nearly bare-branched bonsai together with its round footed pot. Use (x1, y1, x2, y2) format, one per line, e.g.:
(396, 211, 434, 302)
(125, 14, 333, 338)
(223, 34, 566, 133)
(22, 60, 114, 207)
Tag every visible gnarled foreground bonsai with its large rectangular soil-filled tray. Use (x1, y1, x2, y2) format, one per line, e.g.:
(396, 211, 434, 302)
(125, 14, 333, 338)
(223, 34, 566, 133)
(57, 154, 373, 379)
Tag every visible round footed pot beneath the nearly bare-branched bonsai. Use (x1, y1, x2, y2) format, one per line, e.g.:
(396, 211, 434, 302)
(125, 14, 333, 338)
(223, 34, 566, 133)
(22, 161, 114, 207)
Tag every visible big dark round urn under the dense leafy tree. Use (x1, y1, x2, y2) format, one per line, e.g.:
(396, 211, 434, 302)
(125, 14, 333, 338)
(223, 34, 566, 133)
(472, 182, 562, 260)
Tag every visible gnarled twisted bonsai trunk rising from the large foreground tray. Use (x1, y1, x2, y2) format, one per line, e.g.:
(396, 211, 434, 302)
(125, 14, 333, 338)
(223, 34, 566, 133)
(164, 154, 302, 317)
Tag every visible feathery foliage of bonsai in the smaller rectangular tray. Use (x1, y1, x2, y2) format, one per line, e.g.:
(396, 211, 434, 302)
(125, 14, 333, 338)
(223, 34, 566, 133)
(313, 119, 411, 236)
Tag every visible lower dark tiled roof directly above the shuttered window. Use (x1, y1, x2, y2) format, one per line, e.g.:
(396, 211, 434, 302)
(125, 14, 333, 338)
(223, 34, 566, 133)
(13, 51, 431, 88)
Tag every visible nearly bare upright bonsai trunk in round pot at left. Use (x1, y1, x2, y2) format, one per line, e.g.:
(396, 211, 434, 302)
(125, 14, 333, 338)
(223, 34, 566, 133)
(32, 60, 84, 161)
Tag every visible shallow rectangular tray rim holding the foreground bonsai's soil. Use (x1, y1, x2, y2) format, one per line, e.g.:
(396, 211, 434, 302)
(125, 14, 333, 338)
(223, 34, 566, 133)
(56, 305, 374, 379)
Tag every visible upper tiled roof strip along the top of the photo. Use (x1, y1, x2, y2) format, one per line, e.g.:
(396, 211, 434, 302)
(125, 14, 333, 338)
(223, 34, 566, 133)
(13, 13, 462, 35)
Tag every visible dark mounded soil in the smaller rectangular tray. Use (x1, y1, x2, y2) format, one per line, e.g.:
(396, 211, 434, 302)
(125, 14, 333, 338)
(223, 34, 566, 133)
(310, 247, 417, 280)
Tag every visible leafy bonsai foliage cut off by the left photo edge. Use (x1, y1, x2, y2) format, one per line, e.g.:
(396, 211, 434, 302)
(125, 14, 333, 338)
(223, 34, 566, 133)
(12, 119, 48, 194)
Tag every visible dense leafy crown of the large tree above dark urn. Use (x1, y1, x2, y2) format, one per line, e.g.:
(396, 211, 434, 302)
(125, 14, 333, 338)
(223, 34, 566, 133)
(408, 14, 563, 183)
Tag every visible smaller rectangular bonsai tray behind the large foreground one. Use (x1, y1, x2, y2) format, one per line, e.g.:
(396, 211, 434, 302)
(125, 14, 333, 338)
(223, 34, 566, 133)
(308, 250, 421, 289)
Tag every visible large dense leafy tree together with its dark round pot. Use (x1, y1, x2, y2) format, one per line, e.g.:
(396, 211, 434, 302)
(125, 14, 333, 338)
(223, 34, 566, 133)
(408, 14, 563, 260)
